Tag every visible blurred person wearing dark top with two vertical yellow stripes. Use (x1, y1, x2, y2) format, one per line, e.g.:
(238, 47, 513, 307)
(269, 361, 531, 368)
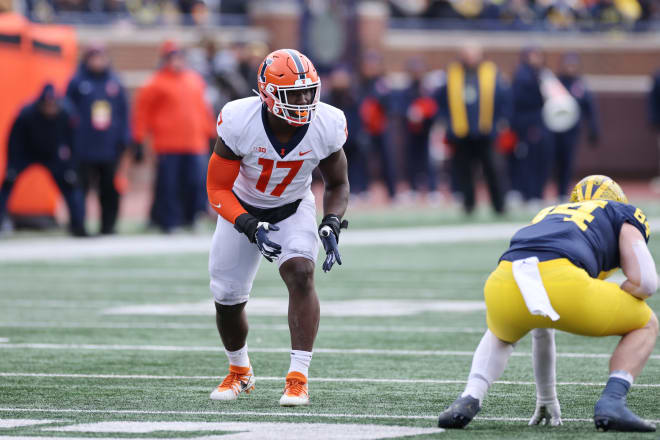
(437, 44, 509, 213)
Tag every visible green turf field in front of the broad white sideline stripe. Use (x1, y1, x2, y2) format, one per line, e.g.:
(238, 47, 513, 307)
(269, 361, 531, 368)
(0, 217, 660, 439)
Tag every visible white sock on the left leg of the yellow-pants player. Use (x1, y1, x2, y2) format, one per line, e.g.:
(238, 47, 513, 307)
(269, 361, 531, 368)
(461, 330, 513, 405)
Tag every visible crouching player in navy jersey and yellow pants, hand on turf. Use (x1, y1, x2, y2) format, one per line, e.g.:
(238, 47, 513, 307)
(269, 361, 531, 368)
(438, 176, 658, 432)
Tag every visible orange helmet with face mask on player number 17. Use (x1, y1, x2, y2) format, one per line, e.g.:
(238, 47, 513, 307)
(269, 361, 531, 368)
(257, 49, 321, 126)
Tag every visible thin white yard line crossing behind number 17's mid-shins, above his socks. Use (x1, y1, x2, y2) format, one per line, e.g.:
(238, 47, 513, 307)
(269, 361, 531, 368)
(0, 321, 486, 336)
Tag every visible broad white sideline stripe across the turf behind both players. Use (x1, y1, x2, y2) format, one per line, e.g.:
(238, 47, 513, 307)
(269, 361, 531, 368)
(0, 218, 660, 261)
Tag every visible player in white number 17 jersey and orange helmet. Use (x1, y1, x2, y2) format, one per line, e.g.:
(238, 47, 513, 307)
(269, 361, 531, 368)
(207, 49, 349, 406)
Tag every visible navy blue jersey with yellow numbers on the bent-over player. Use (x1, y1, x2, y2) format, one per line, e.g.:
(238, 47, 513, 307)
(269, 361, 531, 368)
(501, 200, 651, 278)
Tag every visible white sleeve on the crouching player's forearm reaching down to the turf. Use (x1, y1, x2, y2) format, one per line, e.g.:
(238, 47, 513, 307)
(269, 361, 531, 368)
(532, 328, 557, 403)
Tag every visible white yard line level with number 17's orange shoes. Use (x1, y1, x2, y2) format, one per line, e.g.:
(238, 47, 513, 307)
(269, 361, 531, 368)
(0, 372, 660, 388)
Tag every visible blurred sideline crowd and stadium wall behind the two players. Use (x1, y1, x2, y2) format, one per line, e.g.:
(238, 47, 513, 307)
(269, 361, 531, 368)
(0, 0, 660, 236)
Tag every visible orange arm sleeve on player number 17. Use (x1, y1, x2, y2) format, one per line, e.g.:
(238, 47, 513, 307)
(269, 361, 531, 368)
(206, 153, 247, 223)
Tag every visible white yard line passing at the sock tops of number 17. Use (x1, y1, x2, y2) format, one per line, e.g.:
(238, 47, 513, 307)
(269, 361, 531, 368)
(0, 342, 660, 360)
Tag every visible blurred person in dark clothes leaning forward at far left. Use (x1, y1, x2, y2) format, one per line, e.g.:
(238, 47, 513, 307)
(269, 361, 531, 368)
(0, 84, 87, 237)
